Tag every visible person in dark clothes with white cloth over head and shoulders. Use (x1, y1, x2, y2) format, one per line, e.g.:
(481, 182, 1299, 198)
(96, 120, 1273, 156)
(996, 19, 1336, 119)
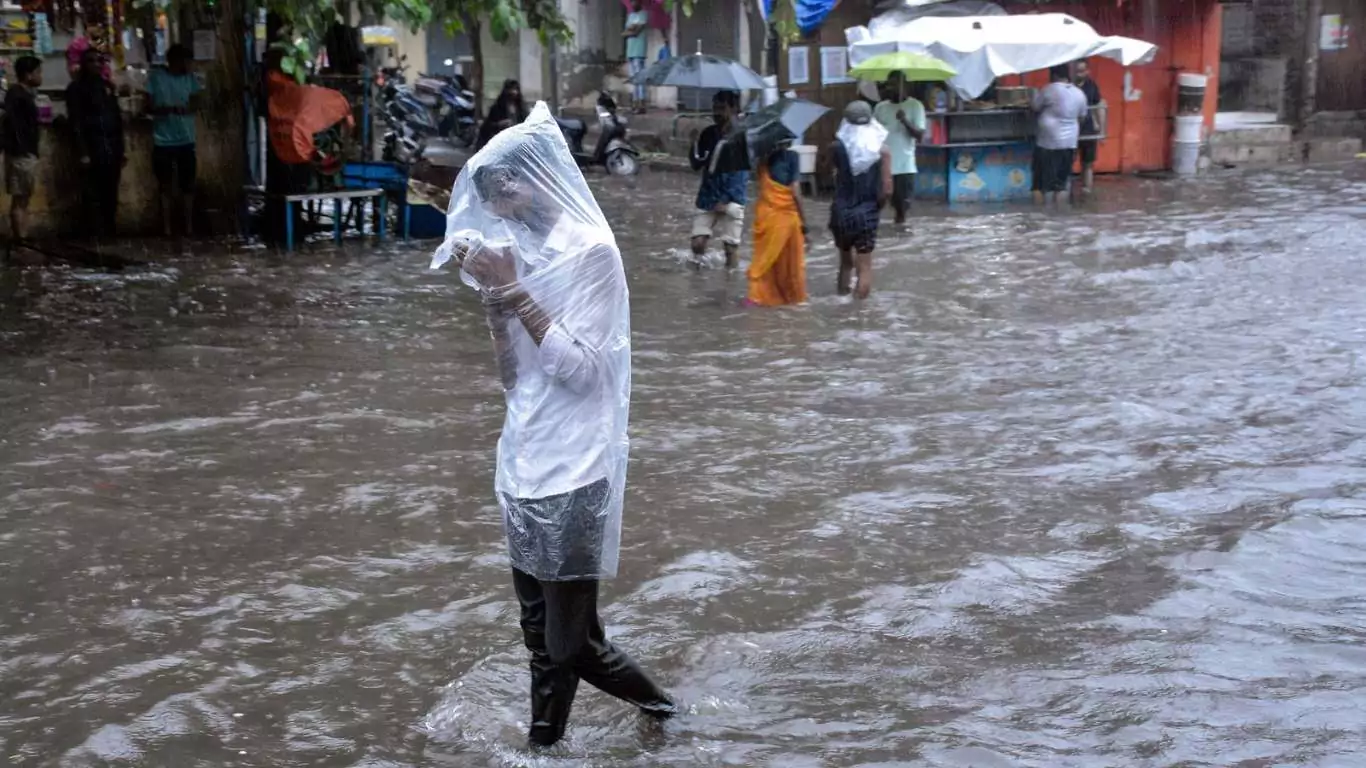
(831, 101, 892, 299)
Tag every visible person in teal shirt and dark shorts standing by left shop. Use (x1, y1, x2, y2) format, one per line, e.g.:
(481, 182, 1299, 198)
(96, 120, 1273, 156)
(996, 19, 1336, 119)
(148, 44, 201, 238)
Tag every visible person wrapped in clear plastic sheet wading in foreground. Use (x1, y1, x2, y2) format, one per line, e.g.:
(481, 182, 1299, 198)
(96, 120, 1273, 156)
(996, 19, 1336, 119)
(432, 102, 675, 746)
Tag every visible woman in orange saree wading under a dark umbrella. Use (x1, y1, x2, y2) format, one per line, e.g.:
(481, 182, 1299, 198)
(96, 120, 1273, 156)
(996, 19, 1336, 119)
(749, 146, 806, 306)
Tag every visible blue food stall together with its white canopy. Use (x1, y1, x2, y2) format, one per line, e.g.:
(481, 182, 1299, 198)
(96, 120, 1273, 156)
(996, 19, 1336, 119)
(846, 14, 1157, 202)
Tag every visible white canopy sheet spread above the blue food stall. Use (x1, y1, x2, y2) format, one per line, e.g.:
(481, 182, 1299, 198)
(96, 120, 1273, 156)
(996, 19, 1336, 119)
(844, 14, 1157, 98)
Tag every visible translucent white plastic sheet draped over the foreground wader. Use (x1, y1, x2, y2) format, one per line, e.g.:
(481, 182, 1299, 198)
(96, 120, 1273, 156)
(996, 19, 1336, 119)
(432, 102, 631, 581)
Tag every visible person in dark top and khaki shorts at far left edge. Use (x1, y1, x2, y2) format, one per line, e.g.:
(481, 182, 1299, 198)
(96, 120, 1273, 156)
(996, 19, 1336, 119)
(0, 56, 42, 243)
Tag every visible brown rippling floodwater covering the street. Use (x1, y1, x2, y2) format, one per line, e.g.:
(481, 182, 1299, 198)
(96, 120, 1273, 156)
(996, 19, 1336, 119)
(0, 163, 1366, 768)
